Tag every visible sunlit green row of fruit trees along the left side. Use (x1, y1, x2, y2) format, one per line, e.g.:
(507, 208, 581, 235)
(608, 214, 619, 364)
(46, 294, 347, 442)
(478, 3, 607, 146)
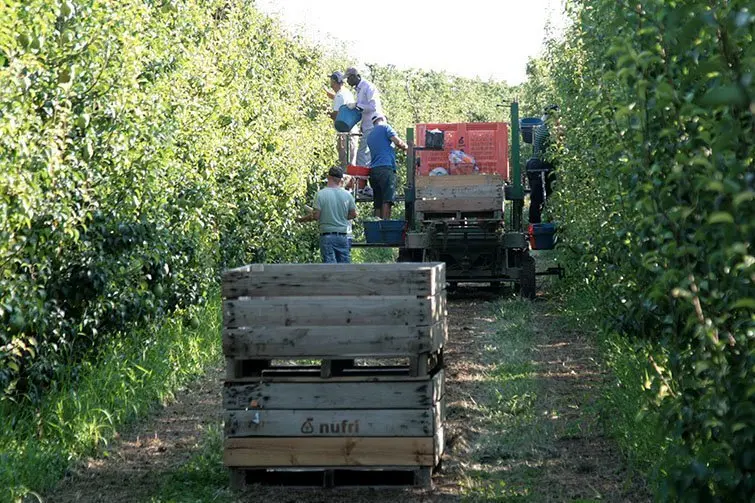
(0, 0, 333, 400)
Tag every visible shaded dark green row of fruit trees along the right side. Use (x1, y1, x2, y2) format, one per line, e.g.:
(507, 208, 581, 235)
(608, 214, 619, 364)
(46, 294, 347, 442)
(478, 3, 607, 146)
(524, 0, 755, 501)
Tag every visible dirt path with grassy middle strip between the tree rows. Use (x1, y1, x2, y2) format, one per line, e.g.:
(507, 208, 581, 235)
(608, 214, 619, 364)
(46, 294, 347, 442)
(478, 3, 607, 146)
(48, 291, 649, 503)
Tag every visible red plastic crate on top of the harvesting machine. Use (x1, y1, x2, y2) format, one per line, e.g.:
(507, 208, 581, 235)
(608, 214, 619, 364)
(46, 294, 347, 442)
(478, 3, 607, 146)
(416, 122, 509, 180)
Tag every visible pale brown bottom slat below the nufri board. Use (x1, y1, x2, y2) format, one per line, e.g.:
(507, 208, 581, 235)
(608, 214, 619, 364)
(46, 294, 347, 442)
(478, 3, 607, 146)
(223, 437, 436, 467)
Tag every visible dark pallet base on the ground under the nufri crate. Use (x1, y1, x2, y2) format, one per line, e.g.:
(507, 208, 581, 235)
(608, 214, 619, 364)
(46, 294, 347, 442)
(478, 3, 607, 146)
(231, 466, 433, 489)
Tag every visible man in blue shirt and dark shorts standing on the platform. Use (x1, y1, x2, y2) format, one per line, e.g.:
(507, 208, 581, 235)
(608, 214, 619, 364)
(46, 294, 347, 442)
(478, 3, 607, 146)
(367, 114, 408, 220)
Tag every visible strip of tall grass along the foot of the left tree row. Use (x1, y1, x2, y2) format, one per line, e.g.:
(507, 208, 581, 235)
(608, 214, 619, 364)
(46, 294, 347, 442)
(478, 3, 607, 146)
(0, 298, 221, 501)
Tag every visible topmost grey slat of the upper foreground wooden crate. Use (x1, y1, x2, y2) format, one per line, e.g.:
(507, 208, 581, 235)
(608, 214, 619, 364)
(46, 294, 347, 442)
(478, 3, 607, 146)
(223, 263, 446, 298)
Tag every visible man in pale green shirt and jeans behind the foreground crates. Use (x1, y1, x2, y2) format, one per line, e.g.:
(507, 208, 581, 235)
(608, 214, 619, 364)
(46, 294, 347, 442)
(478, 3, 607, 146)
(297, 167, 357, 264)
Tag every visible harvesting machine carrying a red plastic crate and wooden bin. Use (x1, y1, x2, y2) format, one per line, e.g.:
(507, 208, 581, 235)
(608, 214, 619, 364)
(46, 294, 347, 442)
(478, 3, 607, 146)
(356, 102, 561, 298)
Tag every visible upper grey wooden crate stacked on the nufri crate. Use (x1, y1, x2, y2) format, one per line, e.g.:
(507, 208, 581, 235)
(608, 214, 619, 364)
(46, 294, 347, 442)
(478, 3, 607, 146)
(223, 263, 448, 379)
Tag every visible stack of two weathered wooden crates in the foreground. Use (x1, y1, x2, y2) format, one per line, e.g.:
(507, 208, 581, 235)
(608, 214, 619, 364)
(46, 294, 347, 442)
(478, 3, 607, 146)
(223, 263, 448, 486)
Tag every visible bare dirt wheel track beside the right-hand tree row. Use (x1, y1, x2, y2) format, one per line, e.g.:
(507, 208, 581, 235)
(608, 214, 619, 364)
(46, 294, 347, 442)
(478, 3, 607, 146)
(533, 302, 651, 502)
